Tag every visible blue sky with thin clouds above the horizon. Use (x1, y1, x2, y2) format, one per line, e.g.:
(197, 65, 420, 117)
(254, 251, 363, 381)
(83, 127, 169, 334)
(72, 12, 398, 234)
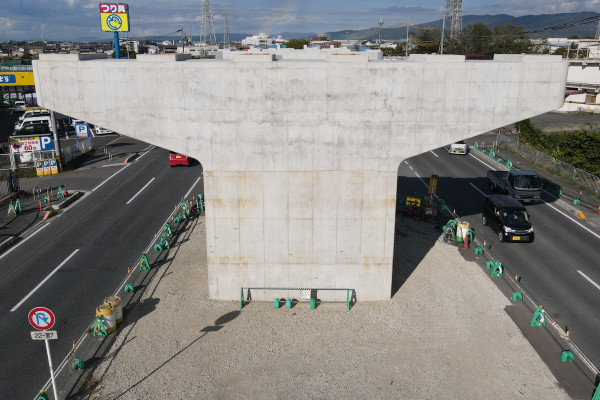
(0, 0, 600, 41)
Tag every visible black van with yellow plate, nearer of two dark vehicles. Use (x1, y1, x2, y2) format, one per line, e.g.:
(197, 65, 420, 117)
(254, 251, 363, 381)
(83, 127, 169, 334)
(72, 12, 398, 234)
(481, 194, 534, 243)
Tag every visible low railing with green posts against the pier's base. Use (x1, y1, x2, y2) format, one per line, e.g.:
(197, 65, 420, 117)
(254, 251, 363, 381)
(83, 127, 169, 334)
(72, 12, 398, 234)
(240, 287, 356, 310)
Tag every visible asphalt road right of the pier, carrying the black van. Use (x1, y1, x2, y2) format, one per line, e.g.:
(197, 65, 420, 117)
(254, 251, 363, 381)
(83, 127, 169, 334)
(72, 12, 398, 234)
(398, 145, 600, 366)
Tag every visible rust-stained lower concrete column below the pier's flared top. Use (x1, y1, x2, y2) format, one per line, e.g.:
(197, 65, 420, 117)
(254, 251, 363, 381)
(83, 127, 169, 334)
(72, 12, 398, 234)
(205, 171, 397, 300)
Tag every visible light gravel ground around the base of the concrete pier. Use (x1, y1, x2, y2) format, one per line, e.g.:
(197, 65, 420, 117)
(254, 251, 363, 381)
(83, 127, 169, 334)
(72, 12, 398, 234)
(89, 218, 568, 399)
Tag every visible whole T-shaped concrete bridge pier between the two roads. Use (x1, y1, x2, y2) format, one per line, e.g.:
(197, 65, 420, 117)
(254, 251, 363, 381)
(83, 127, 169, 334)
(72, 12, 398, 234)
(33, 50, 568, 300)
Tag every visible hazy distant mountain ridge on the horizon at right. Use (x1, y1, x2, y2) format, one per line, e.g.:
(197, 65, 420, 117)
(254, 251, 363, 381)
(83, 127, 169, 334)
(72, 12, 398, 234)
(327, 12, 600, 40)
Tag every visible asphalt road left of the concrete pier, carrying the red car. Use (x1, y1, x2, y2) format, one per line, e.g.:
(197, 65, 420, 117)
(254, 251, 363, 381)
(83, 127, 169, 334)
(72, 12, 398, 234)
(0, 138, 202, 399)
